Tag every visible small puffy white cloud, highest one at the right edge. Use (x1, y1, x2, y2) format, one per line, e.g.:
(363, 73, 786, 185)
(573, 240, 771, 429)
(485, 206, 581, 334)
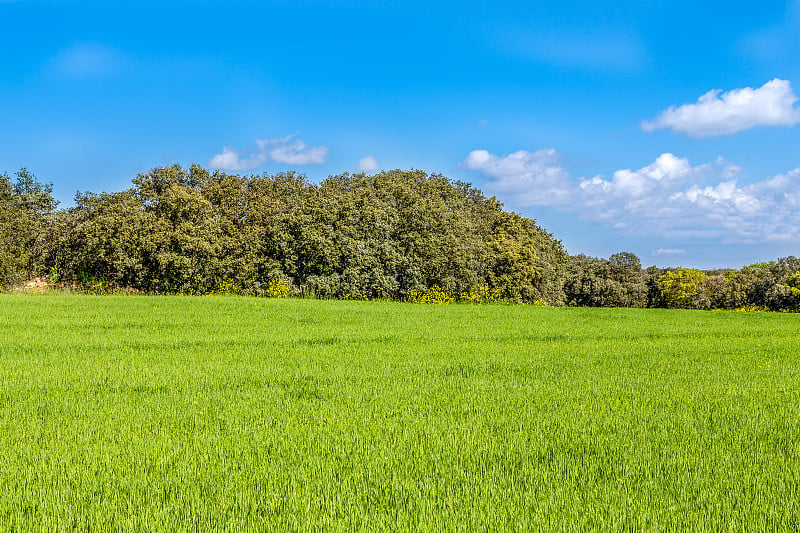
(641, 78, 800, 137)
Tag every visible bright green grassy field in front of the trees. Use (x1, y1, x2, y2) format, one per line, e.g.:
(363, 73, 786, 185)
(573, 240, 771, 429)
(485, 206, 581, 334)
(0, 295, 800, 531)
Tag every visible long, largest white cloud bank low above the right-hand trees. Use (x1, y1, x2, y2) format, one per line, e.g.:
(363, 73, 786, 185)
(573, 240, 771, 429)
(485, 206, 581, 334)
(462, 149, 800, 242)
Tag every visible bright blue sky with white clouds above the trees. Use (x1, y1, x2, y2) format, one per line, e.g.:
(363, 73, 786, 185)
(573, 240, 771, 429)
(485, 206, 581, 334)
(0, 0, 800, 268)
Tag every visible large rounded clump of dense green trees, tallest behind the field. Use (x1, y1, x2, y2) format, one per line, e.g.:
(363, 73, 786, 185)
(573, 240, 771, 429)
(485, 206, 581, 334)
(32, 165, 567, 304)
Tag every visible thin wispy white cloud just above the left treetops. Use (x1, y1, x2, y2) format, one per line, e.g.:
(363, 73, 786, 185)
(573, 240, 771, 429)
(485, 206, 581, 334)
(209, 132, 328, 170)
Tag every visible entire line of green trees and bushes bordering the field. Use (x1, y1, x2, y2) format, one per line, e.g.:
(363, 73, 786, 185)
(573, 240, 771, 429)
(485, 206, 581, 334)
(0, 165, 800, 310)
